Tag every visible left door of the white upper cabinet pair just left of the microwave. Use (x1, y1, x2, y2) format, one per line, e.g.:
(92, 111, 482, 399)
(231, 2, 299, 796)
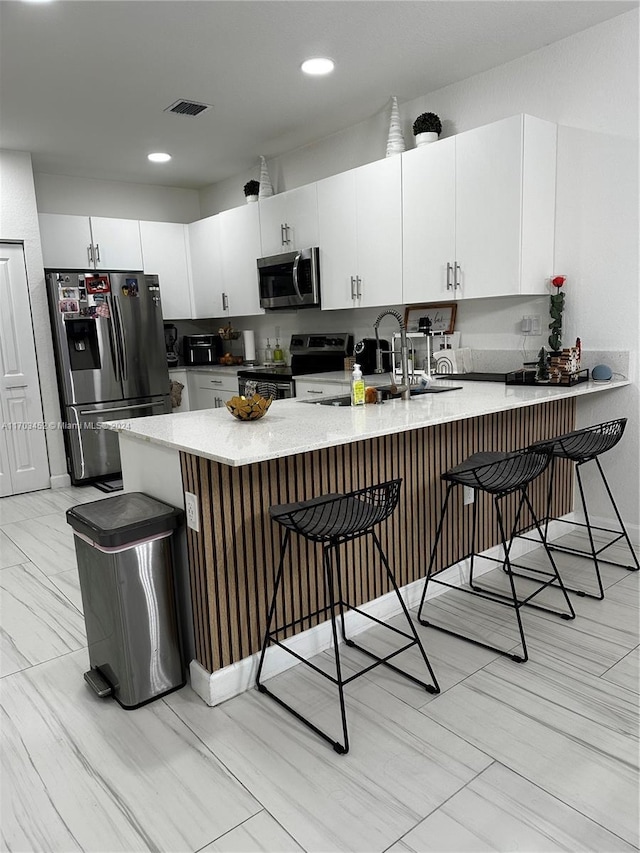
(188, 216, 225, 319)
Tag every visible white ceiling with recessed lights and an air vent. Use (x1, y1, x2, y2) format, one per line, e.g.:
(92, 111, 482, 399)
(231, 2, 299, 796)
(0, 0, 638, 188)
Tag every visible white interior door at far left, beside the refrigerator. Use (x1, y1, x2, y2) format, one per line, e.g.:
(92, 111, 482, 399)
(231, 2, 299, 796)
(0, 243, 50, 496)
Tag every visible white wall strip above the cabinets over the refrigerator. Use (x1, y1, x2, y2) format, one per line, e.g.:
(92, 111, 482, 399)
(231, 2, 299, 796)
(34, 173, 200, 222)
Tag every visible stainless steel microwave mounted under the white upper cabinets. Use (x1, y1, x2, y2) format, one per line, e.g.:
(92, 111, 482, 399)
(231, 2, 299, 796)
(258, 246, 320, 310)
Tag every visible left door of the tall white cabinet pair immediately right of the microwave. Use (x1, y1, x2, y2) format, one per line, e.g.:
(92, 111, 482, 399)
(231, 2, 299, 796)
(316, 169, 358, 308)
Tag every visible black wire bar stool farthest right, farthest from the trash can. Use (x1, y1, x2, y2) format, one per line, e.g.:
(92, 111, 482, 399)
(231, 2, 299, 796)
(523, 418, 640, 601)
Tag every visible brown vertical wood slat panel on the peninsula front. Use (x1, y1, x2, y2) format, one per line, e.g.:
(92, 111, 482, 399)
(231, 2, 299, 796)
(180, 399, 575, 672)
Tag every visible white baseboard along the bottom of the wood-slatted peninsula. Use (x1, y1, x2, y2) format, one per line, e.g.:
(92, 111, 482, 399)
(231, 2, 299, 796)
(189, 516, 573, 707)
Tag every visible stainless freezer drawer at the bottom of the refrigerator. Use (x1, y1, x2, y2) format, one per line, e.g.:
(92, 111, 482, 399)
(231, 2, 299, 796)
(65, 394, 171, 485)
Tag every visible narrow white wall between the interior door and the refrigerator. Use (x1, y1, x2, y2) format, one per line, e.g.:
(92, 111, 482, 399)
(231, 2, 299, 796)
(0, 149, 68, 485)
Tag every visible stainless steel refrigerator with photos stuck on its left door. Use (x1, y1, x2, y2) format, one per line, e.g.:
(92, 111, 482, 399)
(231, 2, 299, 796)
(45, 270, 171, 484)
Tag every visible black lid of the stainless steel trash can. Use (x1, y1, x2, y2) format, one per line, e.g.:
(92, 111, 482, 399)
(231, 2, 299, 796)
(67, 492, 184, 548)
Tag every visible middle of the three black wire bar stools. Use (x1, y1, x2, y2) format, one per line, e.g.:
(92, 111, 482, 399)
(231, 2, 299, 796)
(418, 448, 575, 663)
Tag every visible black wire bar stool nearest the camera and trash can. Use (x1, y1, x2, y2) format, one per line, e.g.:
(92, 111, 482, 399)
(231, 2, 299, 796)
(256, 480, 440, 754)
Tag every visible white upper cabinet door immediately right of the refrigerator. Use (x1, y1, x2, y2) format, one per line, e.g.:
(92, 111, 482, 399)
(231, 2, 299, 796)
(140, 222, 193, 320)
